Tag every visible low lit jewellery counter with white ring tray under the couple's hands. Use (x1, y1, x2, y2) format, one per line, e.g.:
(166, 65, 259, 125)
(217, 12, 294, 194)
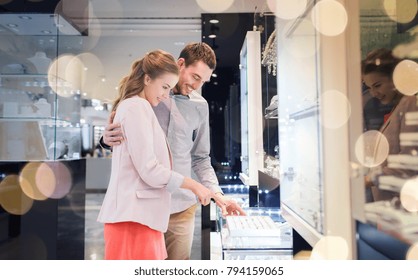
(210, 185, 293, 260)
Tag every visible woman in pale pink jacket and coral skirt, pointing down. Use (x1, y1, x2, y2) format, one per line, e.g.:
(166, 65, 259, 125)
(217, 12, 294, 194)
(98, 50, 222, 260)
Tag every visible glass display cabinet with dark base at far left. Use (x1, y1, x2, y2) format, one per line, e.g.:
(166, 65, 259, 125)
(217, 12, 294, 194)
(0, 11, 86, 260)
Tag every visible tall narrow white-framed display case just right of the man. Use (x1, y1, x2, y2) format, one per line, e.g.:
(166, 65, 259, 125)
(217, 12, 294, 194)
(240, 26, 280, 207)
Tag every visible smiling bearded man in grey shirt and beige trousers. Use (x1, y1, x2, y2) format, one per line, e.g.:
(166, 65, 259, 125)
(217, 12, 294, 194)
(101, 43, 245, 260)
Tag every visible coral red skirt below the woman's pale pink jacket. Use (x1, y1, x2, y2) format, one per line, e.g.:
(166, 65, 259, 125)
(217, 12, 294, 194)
(104, 222, 167, 260)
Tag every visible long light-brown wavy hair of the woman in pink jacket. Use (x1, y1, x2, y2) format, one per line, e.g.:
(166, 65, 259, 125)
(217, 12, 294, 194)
(112, 50, 179, 111)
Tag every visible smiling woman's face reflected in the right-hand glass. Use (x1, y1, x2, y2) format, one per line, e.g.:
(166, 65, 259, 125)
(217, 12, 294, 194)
(363, 72, 397, 104)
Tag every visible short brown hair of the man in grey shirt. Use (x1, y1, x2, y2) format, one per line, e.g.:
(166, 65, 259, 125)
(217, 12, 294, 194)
(179, 42, 216, 70)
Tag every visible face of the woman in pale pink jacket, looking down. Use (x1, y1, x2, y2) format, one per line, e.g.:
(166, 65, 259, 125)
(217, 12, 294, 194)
(143, 73, 179, 107)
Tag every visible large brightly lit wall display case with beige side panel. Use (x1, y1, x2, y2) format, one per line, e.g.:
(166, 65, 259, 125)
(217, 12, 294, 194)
(276, 1, 360, 259)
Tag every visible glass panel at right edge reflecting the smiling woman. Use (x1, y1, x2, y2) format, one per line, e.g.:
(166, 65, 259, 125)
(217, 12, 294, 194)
(356, 0, 418, 243)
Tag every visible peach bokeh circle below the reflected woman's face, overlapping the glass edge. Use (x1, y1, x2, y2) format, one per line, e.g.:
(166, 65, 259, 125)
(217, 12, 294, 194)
(355, 130, 389, 167)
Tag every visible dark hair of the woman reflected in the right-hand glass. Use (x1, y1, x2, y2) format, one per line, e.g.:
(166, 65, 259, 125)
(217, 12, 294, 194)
(361, 48, 401, 78)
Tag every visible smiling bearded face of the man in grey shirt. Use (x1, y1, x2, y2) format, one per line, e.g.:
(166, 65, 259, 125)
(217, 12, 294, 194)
(174, 58, 213, 95)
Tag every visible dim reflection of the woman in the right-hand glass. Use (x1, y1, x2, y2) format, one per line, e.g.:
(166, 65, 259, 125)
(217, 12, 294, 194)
(362, 49, 418, 201)
